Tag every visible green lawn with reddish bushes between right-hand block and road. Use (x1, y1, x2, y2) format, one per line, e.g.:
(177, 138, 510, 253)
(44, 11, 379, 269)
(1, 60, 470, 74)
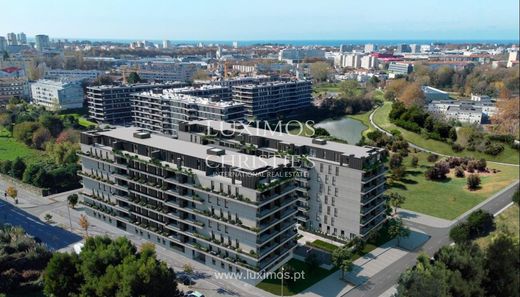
(388, 152, 519, 220)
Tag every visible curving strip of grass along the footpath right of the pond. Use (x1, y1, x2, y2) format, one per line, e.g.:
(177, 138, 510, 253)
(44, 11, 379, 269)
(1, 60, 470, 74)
(374, 101, 520, 164)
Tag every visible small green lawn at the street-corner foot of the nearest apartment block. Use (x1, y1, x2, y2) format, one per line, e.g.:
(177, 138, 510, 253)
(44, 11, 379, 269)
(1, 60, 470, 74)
(256, 259, 337, 296)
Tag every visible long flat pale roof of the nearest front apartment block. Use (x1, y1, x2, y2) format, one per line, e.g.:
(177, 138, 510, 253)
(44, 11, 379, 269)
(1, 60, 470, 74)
(96, 127, 290, 171)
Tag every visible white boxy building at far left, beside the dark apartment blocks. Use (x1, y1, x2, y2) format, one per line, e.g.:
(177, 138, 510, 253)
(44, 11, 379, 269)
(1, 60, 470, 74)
(31, 79, 83, 111)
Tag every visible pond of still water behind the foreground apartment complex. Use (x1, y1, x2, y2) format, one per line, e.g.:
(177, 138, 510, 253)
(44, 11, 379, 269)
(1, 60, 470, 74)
(315, 117, 368, 144)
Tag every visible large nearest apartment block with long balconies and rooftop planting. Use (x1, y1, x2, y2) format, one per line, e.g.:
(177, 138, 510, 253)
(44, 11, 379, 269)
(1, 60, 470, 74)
(79, 127, 298, 284)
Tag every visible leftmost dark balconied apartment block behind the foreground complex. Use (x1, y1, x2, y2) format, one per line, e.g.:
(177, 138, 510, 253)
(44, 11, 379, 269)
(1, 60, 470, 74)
(87, 82, 186, 124)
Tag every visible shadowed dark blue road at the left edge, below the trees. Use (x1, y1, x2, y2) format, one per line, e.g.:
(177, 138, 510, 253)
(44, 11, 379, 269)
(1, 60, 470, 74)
(0, 201, 82, 250)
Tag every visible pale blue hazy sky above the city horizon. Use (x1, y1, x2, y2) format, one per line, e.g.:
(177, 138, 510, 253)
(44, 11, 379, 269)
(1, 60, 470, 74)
(0, 0, 519, 40)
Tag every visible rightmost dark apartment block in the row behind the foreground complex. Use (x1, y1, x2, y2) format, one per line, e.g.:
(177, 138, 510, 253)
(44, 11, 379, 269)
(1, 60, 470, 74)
(232, 80, 312, 120)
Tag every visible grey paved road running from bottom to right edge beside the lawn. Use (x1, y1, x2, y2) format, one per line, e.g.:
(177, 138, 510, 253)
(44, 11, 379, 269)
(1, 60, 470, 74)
(343, 182, 518, 297)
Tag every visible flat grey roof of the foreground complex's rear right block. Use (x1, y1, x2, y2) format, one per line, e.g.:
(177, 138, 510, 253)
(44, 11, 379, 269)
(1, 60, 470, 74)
(189, 120, 379, 158)
